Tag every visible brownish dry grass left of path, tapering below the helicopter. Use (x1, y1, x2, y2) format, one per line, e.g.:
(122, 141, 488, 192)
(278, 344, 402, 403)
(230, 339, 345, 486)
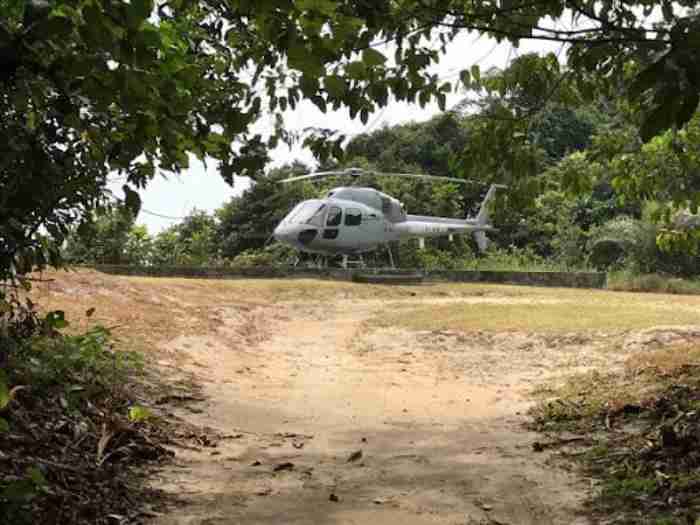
(26, 270, 448, 353)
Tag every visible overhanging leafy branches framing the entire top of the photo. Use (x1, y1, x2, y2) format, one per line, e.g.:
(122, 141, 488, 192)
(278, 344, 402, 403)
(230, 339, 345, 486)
(0, 0, 700, 284)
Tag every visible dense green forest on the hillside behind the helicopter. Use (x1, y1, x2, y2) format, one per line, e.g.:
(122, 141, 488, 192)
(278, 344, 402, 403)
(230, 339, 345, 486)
(64, 55, 700, 276)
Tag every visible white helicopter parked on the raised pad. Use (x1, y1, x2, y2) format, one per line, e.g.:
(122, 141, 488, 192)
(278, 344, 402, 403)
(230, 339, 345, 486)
(273, 168, 506, 268)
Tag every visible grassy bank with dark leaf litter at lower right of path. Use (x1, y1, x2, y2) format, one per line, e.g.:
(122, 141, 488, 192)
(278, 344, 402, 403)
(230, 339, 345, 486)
(532, 345, 700, 525)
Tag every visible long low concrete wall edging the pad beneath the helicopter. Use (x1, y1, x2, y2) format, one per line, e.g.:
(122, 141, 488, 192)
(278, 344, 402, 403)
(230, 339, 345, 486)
(93, 265, 607, 288)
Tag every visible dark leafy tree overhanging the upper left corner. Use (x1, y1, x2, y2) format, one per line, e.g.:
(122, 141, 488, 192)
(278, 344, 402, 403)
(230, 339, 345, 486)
(0, 0, 464, 278)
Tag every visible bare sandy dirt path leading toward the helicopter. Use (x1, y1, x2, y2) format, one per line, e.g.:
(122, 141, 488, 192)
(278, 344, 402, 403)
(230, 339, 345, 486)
(149, 300, 605, 525)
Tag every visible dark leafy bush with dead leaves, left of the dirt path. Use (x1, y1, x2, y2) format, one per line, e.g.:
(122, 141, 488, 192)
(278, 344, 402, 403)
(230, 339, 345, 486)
(0, 307, 146, 525)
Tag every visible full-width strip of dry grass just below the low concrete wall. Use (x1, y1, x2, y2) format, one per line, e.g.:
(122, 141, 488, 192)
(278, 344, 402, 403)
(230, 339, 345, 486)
(32, 270, 700, 350)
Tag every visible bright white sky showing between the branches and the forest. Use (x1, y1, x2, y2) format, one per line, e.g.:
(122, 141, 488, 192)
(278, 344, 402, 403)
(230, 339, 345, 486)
(106, 33, 563, 234)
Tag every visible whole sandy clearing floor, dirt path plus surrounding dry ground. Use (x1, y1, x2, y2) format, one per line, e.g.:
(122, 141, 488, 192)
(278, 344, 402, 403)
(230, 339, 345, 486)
(34, 271, 700, 525)
